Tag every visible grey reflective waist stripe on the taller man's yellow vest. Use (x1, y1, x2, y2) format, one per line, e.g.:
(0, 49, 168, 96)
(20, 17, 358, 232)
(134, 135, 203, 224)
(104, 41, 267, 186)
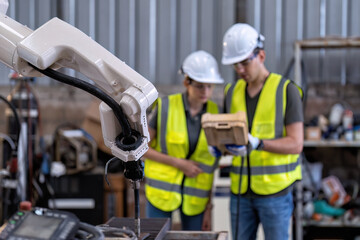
(231, 157, 300, 175)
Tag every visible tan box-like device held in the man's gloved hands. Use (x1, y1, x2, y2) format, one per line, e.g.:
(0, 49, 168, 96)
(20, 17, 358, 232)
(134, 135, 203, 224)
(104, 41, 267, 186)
(201, 111, 248, 152)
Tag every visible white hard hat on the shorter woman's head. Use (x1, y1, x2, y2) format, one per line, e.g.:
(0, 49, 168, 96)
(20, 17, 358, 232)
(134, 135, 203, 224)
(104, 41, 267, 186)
(181, 50, 224, 83)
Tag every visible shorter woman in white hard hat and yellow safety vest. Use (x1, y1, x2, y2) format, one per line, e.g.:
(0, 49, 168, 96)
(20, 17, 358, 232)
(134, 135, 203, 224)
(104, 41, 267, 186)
(144, 51, 223, 230)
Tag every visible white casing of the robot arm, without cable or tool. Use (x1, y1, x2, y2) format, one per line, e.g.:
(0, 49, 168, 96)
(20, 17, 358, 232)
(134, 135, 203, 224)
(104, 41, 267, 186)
(0, 14, 158, 161)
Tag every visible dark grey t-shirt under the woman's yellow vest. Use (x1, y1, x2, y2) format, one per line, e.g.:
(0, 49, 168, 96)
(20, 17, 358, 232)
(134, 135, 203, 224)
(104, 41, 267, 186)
(148, 93, 207, 158)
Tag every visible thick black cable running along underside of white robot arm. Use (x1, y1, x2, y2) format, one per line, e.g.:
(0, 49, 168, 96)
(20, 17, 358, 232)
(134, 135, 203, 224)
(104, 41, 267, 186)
(30, 64, 131, 137)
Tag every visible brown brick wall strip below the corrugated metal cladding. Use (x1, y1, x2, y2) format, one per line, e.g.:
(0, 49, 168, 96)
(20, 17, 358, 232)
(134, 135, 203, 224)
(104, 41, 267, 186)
(0, 84, 360, 142)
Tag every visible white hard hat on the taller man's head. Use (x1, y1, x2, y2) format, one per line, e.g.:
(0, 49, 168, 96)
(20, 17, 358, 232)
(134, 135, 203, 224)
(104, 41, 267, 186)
(221, 23, 265, 65)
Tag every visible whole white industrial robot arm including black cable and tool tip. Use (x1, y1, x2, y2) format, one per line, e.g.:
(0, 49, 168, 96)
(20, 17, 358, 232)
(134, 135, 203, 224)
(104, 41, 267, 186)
(0, 0, 158, 236)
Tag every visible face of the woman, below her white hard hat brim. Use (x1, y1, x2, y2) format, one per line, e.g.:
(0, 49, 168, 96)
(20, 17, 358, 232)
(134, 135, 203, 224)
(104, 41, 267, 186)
(184, 78, 214, 104)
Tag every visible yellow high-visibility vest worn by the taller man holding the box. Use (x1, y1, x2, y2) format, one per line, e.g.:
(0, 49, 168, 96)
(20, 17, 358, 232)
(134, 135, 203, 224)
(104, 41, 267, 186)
(225, 73, 302, 195)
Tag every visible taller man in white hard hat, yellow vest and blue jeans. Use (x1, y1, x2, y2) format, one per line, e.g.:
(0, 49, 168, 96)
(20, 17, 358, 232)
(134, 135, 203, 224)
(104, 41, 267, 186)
(211, 23, 303, 240)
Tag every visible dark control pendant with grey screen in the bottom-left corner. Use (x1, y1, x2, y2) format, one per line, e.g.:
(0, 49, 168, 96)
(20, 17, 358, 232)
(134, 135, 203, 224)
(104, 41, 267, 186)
(0, 208, 80, 240)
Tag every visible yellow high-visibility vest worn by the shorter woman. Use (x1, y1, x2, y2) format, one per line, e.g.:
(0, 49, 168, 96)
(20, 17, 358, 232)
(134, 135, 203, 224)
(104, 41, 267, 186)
(145, 94, 218, 216)
